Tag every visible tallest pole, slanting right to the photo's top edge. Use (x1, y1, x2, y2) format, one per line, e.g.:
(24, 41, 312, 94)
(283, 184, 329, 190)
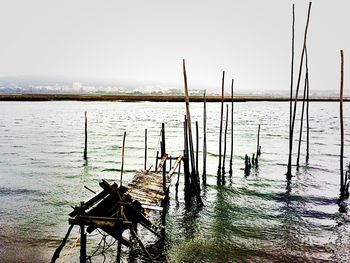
(287, 2, 312, 180)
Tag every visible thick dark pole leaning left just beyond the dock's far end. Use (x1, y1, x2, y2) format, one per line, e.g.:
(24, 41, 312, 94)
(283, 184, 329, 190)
(182, 59, 203, 206)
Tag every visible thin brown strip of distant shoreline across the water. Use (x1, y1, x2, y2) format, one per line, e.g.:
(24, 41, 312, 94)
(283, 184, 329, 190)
(0, 94, 350, 102)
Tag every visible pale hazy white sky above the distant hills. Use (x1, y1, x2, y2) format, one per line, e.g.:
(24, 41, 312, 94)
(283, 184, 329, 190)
(0, 0, 350, 91)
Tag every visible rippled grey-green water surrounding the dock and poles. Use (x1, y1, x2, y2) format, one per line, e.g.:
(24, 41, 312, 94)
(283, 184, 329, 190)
(0, 102, 350, 262)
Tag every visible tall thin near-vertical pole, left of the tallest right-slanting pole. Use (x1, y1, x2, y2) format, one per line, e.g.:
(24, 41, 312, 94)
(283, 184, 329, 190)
(286, 4, 295, 180)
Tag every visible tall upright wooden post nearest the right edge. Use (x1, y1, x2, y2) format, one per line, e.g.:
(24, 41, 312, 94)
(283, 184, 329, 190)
(339, 50, 345, 199)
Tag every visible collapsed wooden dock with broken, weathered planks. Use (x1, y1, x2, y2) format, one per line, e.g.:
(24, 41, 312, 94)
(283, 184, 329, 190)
(51, 154, 183, 262)
